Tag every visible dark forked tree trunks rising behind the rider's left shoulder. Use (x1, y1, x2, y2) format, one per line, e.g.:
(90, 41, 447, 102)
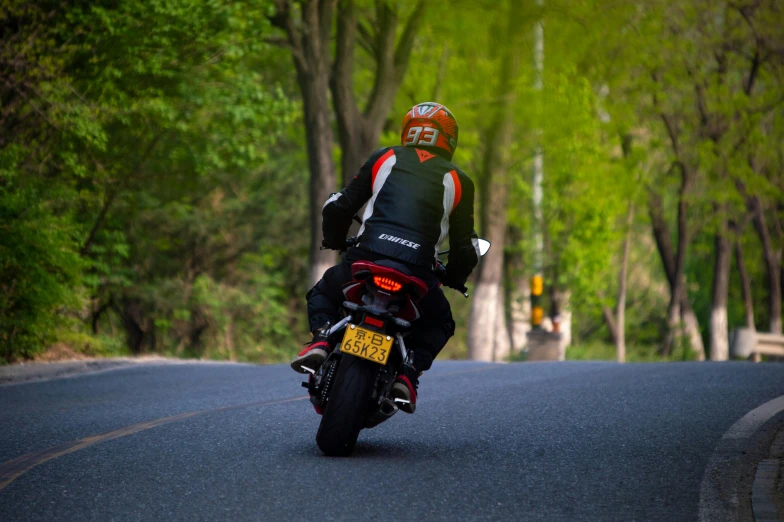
(270, 0, 425, 285)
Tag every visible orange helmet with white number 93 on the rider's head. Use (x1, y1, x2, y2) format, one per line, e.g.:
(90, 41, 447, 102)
(400, 102, 457, 159)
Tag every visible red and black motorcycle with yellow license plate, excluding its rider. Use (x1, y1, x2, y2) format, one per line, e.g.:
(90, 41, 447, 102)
(302, 233, 490, 456)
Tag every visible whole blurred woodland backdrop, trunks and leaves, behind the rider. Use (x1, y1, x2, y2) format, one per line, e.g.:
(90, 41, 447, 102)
(0, 0, 784, 362)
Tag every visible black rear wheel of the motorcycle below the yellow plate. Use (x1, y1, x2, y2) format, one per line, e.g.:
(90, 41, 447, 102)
(316, 354, 379, 457)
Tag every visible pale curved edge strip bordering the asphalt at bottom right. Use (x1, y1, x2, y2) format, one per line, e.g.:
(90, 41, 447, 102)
(698, 395, 784, 522)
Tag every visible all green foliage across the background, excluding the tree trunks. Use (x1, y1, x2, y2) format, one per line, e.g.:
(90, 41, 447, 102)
(0, 0, 784, 362)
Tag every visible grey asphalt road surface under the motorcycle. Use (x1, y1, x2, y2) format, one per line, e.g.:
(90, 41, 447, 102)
(0, 362, 784, 521)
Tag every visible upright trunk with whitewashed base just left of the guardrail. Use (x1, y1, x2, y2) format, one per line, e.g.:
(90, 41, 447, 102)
(710, 215, 732, 361)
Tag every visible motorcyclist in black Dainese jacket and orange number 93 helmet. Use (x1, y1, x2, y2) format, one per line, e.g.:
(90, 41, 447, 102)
(291, 102, 479, 413)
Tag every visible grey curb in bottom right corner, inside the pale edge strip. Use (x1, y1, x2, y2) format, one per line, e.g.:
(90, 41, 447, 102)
(751, 428, 784, 522)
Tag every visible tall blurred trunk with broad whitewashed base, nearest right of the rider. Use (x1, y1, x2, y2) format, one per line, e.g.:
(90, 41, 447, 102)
(468, 0, 523, 361)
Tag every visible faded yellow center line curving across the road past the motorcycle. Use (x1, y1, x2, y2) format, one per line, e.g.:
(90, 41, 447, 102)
(0, 364, 504, 491)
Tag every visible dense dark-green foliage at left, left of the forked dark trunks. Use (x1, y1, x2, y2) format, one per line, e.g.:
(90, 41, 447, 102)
(0, 0, 297, 360)
